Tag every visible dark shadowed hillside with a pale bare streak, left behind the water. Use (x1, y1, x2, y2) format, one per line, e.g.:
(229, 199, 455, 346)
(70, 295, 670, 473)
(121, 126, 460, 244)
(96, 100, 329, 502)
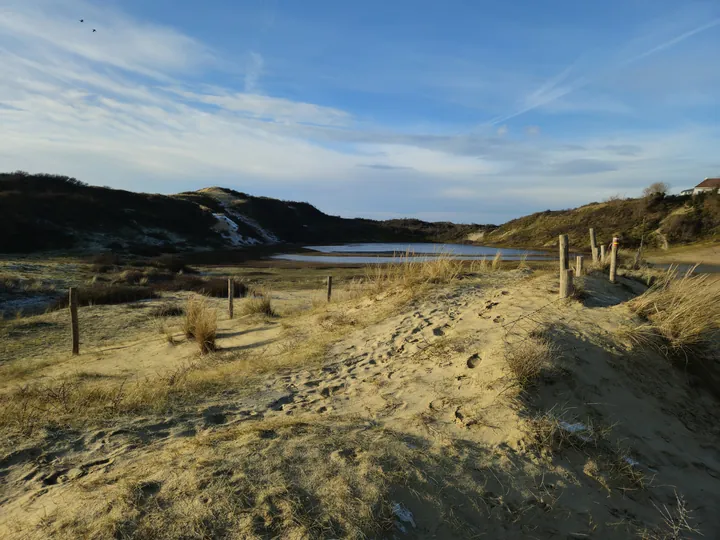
(0, 171, 492, 254)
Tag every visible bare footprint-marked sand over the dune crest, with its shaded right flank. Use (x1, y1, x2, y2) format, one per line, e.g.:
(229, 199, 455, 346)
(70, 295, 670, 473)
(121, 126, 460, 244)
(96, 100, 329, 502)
(0, 272, 720, 539)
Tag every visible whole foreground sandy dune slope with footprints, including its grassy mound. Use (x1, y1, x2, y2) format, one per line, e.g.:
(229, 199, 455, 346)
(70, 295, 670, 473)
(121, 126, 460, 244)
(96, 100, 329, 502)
(0, 271, 720, 539)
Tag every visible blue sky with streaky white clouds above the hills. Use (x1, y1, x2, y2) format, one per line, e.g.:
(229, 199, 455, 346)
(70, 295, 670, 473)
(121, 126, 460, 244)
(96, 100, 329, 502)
(0, 0, 720, 224)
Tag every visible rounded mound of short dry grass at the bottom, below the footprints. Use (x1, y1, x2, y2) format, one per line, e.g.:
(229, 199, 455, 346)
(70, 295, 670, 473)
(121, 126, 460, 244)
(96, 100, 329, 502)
(14, 416, 556, 540)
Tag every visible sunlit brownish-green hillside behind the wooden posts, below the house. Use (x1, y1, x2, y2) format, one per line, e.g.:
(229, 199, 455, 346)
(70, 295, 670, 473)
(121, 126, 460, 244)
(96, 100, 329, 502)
(478, 193, 720, 247)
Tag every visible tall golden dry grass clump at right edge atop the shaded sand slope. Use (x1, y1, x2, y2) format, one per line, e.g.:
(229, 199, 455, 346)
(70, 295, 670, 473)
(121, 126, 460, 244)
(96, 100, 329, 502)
(628, 268, 720, 361)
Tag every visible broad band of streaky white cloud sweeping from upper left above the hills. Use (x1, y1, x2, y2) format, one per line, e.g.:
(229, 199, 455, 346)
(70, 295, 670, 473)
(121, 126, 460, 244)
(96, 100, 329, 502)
(0, 0, 720, 222)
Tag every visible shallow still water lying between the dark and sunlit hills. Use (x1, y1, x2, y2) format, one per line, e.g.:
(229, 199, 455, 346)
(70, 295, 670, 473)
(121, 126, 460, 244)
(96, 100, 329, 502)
(273, 242, 556, 264)
